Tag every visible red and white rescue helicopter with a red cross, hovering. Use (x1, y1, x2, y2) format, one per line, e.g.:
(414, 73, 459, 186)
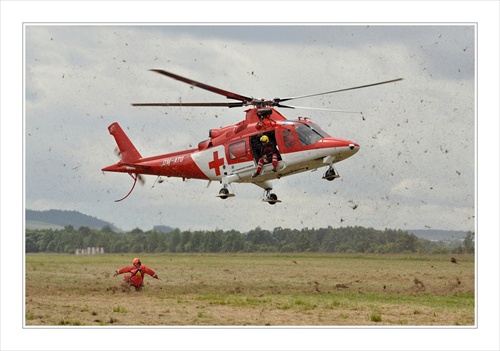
(102, 69, 402, 205)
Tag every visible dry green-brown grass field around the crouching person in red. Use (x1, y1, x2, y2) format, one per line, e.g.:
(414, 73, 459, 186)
(25, 254, 475, 326)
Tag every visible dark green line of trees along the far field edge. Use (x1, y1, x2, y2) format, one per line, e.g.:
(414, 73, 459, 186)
(25, 226, 474, 254)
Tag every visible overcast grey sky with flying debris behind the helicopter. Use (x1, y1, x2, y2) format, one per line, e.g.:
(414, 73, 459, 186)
(25, 24, 476, 231)
